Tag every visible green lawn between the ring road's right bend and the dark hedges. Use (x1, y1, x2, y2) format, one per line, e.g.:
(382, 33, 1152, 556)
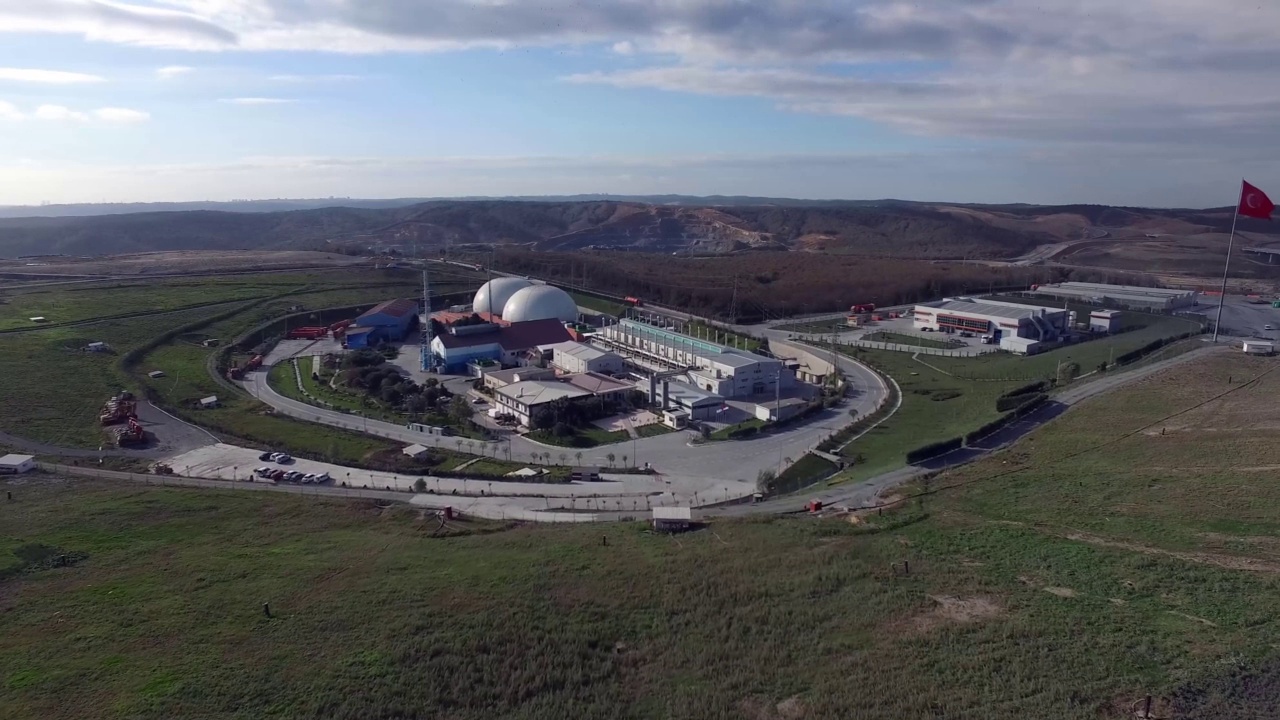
(838, 347, 1021, 480)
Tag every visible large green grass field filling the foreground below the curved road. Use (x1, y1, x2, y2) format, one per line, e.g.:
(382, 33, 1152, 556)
(0, 355, 1280, 720)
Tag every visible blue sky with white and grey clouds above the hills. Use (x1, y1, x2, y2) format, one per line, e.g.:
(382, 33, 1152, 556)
(0, 0, 1280, 206)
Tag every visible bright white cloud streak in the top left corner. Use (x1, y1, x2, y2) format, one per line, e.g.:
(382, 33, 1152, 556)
(0, 0, 238, 50)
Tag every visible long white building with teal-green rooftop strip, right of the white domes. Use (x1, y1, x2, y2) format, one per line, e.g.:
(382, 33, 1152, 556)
(594, 320, 796, 397)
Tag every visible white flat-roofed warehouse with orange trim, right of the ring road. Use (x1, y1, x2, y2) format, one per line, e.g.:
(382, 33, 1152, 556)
(913, 297, 1074, 355)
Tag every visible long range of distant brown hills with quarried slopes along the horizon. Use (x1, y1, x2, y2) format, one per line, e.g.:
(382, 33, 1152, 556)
(0, 196, 1270, 260)
